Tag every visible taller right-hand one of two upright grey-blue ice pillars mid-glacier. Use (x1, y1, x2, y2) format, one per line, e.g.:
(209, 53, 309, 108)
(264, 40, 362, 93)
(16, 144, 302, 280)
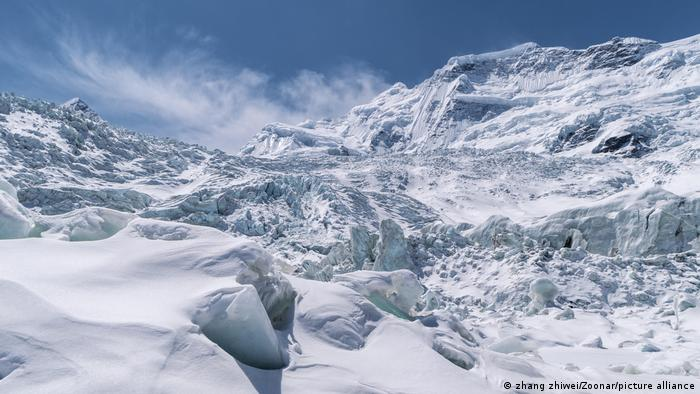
(374, 219, 415, 271)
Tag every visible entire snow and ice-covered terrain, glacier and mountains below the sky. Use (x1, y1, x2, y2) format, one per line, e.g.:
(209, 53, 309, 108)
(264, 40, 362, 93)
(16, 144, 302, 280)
(0, 36, 700, 393)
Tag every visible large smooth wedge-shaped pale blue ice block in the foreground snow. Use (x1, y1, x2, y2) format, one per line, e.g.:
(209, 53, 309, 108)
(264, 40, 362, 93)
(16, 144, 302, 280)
(194, 285, 288, 369)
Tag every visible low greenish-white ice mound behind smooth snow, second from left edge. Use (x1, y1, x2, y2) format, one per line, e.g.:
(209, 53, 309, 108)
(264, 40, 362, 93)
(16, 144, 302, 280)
(34, 207, 136, 242)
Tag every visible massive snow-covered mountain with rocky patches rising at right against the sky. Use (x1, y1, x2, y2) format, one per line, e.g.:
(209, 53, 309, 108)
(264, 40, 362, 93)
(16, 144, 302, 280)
(244, 36, 700, 162)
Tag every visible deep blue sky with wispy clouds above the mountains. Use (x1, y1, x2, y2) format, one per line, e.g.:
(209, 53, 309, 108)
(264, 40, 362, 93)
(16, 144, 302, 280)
(0, 0, 700, 151)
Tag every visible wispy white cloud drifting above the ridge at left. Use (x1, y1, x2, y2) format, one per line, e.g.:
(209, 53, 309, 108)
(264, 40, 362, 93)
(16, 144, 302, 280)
(0, 30, 387, 151)
